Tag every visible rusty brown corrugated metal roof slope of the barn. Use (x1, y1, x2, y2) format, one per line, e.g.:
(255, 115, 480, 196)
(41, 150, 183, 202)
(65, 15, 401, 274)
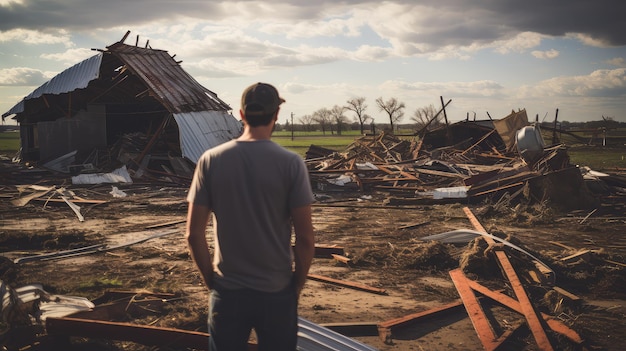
(107, 43, 232, 113)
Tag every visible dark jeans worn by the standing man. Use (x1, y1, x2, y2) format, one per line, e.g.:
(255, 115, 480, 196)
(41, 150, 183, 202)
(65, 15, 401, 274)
(209, 286, 298, 351)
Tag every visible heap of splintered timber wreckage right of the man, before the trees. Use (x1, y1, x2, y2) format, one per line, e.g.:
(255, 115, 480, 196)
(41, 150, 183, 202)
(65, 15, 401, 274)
(306, 110, 613, 210)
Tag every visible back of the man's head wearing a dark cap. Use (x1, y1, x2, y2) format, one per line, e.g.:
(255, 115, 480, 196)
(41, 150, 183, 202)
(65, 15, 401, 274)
(241, 83, 285, 127)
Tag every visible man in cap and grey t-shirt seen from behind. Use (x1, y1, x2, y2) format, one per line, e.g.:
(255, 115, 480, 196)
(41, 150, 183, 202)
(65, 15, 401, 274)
(186, 83, 315, 351)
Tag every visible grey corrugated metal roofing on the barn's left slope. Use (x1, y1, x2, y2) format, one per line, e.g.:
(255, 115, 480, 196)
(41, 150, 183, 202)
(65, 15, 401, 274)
(2, 53, 102, 117)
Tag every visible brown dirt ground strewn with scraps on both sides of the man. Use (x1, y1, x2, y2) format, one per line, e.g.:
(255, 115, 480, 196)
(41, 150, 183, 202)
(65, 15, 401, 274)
(0, 163, 626, 351)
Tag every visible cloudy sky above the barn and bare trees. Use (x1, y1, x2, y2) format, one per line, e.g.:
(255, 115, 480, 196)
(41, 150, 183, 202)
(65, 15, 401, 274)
(0, 0, 626, 123)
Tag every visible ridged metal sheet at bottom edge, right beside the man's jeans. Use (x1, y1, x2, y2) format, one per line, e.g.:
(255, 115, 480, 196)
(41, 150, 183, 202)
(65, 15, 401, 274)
(296, 317, 377, 351)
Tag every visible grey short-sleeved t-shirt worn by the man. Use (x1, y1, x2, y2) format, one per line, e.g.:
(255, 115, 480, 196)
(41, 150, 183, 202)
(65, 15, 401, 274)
(187, 140, 313, 292)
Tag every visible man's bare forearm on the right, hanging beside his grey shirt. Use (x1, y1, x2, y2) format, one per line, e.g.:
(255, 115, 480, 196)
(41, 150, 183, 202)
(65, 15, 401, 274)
(291, 205, 315, 296)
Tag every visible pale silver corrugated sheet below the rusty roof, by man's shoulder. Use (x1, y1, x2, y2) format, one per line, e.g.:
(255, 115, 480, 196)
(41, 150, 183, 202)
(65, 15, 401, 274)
(174, 111, 242, 163)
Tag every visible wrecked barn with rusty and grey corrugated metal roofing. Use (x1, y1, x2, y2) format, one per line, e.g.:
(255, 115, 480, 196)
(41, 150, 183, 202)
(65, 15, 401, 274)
(2, 33, 241, 176)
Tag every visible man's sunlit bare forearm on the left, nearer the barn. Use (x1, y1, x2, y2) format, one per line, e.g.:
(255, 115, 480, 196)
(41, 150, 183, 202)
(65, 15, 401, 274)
(185, 202, 213, 289)
